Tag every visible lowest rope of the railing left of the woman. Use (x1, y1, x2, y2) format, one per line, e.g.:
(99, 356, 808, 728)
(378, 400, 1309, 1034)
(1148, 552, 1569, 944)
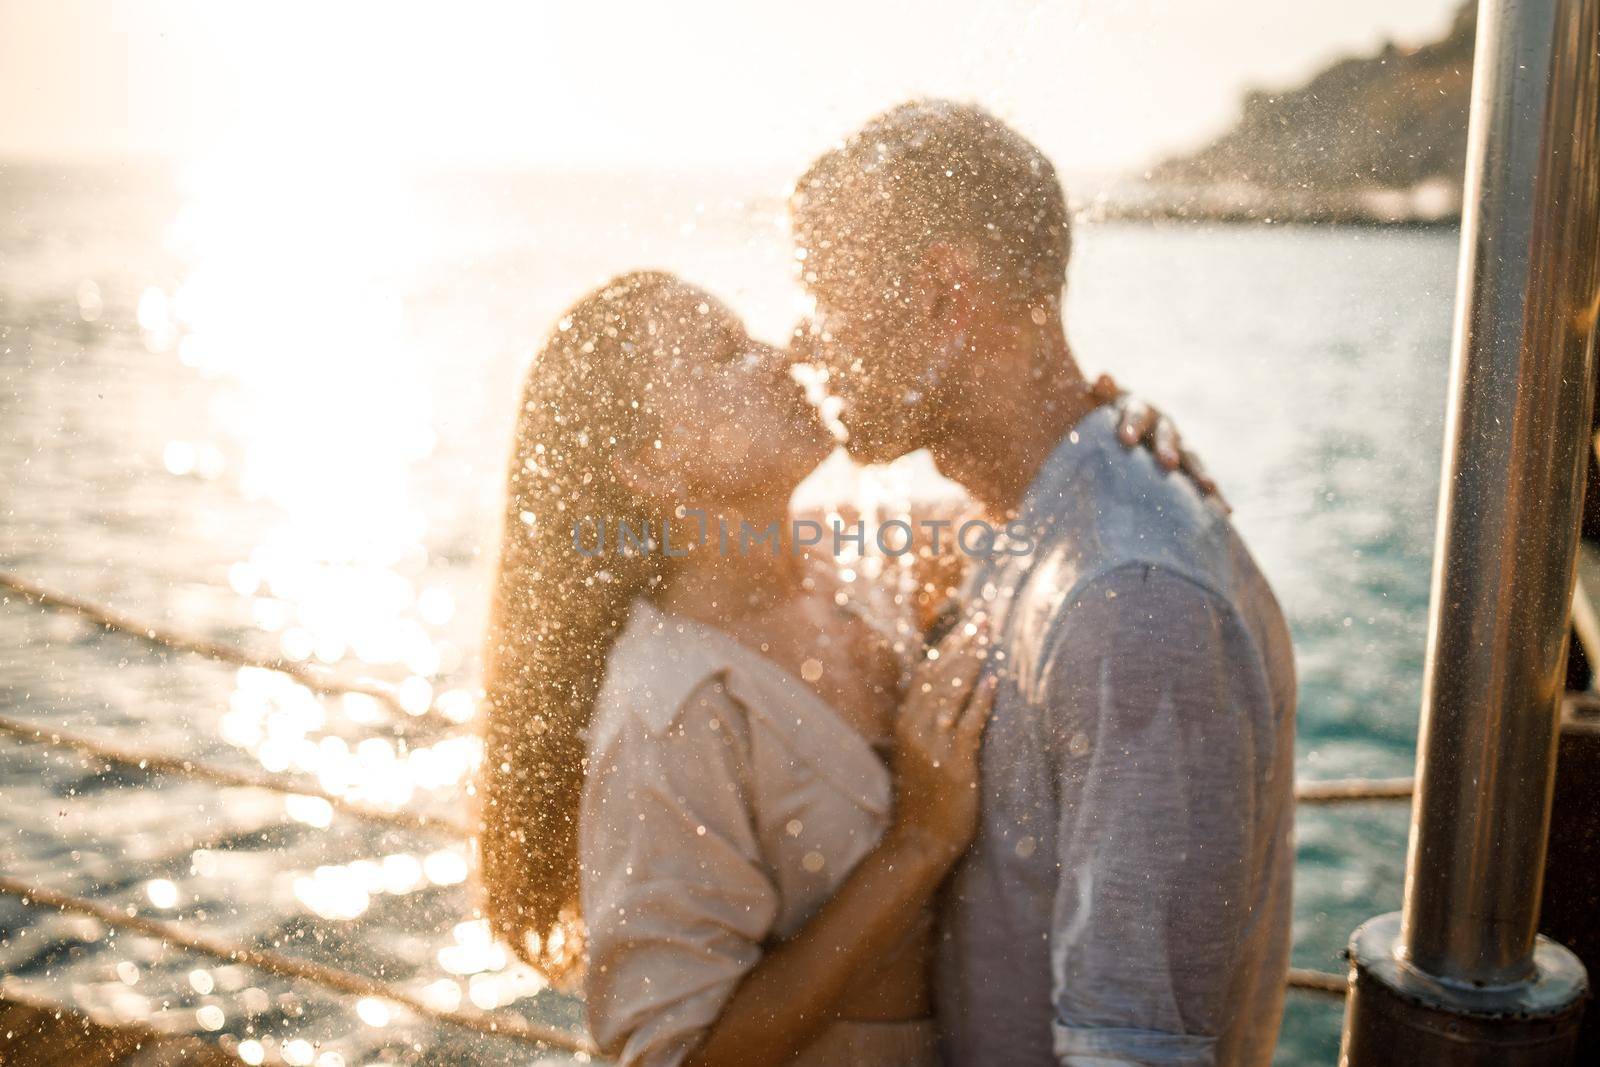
(0, 875, 595, 1053)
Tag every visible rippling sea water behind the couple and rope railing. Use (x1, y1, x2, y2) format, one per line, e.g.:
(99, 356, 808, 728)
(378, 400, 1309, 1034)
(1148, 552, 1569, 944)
(0, 160, 1456, 1067)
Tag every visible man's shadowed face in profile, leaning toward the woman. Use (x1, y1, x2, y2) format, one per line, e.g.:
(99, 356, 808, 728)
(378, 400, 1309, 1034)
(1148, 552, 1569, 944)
(803, 271, 950, 462)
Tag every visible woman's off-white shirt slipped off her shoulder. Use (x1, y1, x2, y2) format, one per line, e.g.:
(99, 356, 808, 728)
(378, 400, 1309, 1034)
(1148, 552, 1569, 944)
(579, 601, 891, 1067)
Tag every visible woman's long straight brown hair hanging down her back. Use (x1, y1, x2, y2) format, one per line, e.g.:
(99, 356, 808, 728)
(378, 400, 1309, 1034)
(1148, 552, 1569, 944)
(477, 272, 682, 981)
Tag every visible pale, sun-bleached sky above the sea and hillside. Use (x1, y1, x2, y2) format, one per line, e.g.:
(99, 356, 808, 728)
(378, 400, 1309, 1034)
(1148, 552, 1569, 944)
(0, 0, 1456, 174)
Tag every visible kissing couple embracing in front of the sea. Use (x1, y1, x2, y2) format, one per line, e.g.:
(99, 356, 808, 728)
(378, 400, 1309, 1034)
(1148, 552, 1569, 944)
(477, 101, 1294, 1067)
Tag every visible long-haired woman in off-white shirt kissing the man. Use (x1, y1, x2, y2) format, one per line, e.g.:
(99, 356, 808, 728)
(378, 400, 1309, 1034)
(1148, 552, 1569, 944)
(478, 274, 1203, 1067)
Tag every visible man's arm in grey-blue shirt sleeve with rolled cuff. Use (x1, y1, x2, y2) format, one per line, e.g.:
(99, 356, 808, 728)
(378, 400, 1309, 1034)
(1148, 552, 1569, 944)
(1043, 566, 1274, 1067)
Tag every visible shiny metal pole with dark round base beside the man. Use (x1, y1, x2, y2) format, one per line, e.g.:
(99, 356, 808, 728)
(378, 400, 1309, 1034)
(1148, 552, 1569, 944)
(1344, 0, 1600, 1067)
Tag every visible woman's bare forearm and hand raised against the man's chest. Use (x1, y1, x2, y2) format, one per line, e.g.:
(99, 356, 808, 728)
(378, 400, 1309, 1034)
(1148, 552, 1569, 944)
(688, 627, 994, 1067)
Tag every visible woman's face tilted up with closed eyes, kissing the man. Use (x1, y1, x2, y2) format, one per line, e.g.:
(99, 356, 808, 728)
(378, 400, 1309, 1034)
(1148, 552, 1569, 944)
(638, 286, 834, 509)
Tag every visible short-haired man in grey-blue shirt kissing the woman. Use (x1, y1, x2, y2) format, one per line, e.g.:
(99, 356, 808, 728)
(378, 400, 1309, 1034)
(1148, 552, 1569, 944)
(790, 101, 1294, 1067)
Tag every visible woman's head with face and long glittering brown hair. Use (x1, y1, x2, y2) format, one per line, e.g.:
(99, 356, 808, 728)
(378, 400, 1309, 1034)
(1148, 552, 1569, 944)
(478, 272, 829, 976)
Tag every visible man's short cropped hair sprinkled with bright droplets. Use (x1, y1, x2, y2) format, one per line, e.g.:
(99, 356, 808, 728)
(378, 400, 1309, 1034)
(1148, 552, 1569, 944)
(789, 99, 1072, 298)
